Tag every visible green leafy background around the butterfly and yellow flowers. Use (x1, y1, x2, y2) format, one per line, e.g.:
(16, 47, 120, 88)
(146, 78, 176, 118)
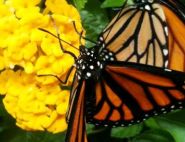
(0, 0, 185, 142)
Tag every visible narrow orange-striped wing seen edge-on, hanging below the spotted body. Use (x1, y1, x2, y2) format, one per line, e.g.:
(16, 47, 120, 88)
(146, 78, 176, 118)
(65, 81, 87, 142)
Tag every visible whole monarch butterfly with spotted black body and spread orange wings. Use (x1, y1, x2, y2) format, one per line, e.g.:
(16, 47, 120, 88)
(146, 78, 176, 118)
(39, 0, 185, 142)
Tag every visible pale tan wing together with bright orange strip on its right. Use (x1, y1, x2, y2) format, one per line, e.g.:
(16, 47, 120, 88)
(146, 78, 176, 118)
(99, 0, 185, 71)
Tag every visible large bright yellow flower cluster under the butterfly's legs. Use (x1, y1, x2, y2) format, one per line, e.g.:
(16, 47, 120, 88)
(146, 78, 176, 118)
(0, 0, 82, 133)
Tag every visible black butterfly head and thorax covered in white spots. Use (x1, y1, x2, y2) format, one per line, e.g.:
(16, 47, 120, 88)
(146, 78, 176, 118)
(75, 47, 115, 81)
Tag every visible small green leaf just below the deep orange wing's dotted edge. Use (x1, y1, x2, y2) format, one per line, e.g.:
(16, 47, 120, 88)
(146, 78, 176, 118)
(111, 123, 143, 138)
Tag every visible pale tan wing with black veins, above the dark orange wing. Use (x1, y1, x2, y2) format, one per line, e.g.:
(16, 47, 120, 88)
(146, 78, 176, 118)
(99, 2, 168, 67)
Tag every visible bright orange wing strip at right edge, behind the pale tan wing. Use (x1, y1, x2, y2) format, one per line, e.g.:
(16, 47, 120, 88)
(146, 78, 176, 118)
(161, 1, 185, 72)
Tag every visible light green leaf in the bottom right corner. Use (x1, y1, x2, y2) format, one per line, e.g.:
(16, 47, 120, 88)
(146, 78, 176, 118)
(156, 117, 185, 142)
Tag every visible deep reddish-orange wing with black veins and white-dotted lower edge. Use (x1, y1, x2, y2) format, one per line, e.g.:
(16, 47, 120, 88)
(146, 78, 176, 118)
(86, 62, 185, 126)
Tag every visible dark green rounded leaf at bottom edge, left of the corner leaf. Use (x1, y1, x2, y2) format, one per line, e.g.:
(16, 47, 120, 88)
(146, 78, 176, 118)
(131, 129, 175, 142)
